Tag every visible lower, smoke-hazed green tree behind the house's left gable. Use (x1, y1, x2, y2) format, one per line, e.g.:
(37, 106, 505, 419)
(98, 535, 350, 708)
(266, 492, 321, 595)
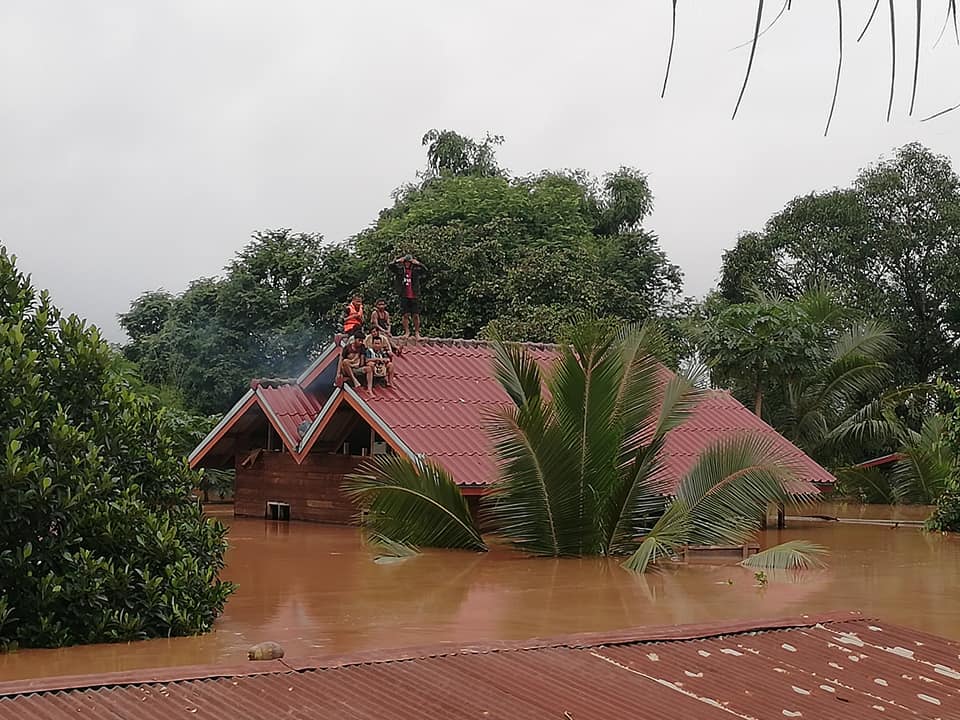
(120, 230, 362, 414)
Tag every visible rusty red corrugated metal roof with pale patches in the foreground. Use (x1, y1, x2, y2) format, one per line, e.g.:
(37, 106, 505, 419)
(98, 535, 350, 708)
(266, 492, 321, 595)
(0, 614, 960, 720)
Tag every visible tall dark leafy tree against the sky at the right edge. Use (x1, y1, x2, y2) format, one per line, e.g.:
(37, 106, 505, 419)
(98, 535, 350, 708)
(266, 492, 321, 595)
(720, 143, 960, 384)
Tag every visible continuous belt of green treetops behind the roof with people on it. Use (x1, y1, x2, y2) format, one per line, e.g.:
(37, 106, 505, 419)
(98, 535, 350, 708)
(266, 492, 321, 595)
(120, 130, 682, 413)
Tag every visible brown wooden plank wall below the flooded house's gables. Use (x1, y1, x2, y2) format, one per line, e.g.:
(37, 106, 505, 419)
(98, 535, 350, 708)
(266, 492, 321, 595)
(233, 451, 366, 525)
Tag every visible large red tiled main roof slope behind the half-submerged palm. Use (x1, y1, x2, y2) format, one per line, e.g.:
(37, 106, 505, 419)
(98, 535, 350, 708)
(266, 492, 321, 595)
(367, 341, 834, 494)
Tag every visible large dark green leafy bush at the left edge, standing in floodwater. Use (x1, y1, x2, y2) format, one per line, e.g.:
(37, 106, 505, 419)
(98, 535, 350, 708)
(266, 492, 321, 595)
(0, 247, 233, 649)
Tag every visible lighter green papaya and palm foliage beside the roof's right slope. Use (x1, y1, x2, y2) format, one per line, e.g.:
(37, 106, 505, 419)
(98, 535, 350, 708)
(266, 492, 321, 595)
(697, 287, 900, 467)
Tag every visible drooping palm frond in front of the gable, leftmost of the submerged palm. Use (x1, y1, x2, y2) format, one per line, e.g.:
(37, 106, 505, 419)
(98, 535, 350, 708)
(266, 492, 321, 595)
(343, 456, 486, 550)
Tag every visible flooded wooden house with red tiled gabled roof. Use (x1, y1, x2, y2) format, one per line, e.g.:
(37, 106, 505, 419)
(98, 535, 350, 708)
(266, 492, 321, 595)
(189, 340, 835, 523)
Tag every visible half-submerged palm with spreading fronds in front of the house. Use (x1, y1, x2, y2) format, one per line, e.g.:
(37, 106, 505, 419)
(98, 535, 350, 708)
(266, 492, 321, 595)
(345, 321, 818, 572)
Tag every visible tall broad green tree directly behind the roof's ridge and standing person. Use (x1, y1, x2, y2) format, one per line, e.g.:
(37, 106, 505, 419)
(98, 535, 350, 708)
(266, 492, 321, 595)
(355, 136, 682, 341)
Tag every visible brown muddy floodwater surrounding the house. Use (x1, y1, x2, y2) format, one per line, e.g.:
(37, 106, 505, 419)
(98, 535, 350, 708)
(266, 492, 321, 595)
(0, 506, 960, 680)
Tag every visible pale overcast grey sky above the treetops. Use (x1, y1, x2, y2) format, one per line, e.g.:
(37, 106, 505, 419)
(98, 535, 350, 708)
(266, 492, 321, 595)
(0, 0, 960, 340)
